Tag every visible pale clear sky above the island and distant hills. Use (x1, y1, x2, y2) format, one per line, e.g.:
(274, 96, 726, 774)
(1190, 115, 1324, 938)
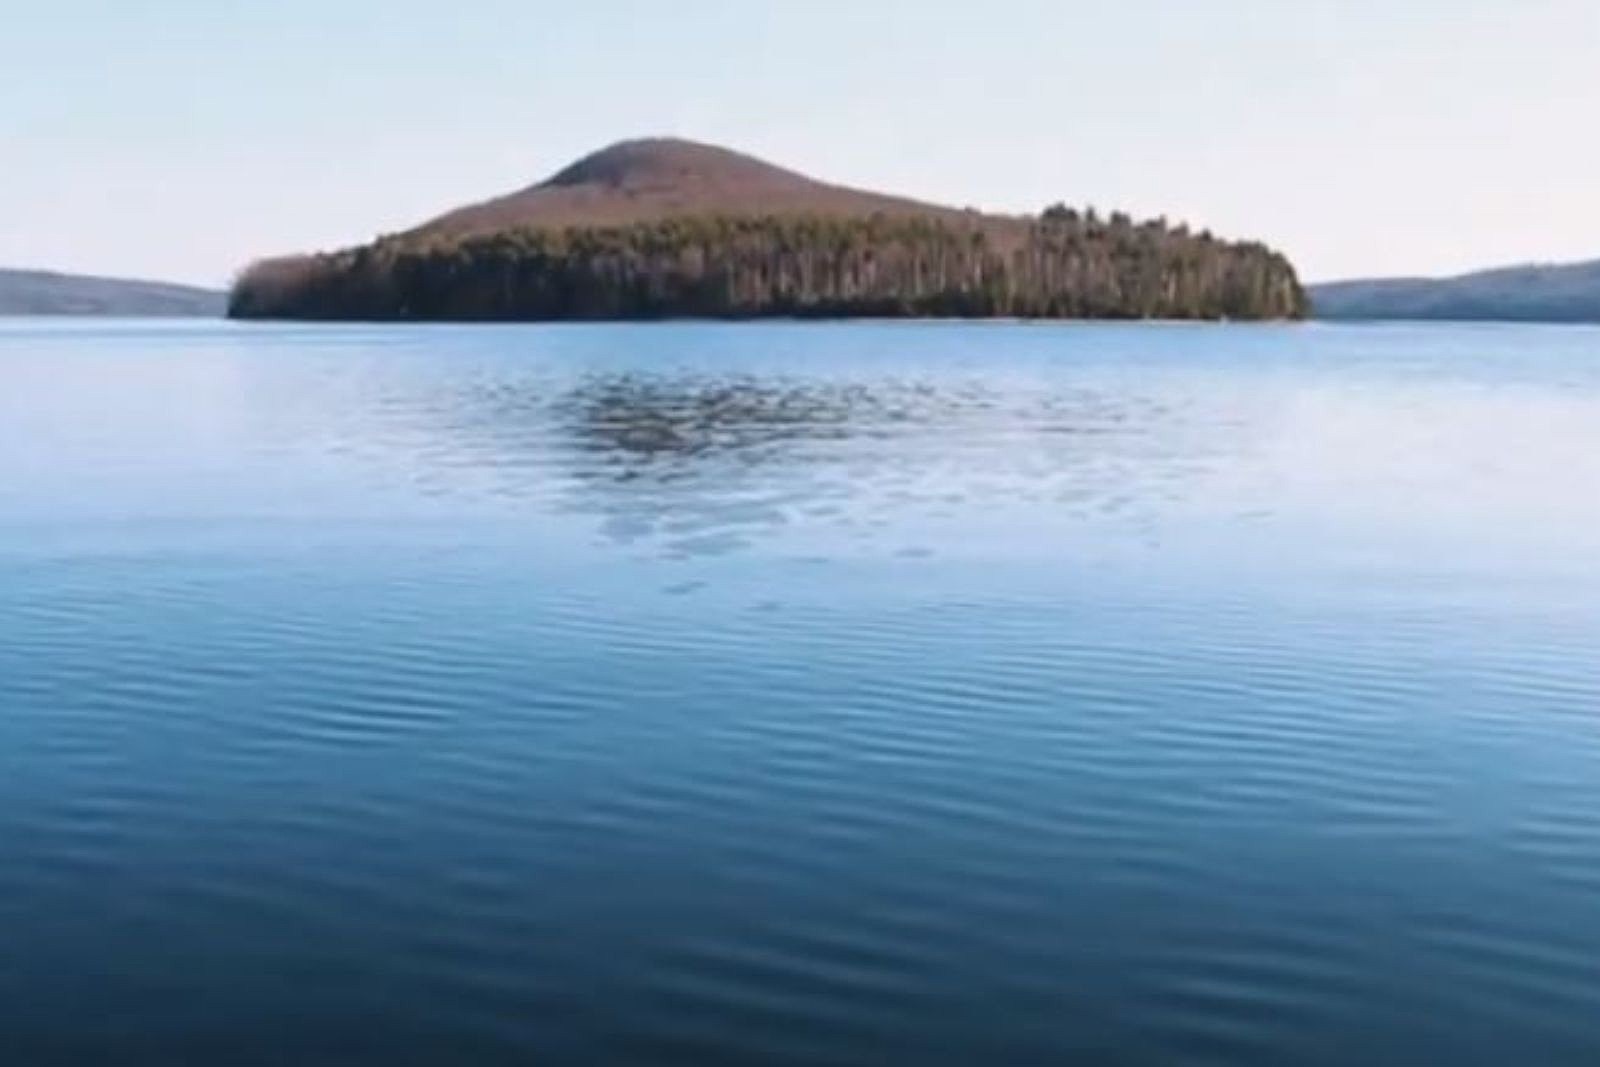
(0, 0, 1600, 283)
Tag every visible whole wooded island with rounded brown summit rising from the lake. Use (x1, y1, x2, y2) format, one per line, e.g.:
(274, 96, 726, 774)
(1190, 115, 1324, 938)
(229, 139, 1306, 320)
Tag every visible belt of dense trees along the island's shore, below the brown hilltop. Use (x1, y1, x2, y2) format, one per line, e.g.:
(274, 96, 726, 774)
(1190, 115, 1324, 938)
(230, 208, 1306, 320)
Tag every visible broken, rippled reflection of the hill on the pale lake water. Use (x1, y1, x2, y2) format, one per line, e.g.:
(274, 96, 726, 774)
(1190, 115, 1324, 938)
(409, 373, 1222, 553)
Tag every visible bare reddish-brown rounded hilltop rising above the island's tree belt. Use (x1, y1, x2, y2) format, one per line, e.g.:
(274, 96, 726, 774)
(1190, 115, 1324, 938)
(411, 138, 995, 237)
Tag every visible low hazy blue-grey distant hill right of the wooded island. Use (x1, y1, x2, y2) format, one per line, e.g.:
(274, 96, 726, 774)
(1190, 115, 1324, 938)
(1310, 259, 1600, 322)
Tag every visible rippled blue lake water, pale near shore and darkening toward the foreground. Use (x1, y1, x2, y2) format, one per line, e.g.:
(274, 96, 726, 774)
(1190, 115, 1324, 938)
(0, 320, 1600, 1065)
